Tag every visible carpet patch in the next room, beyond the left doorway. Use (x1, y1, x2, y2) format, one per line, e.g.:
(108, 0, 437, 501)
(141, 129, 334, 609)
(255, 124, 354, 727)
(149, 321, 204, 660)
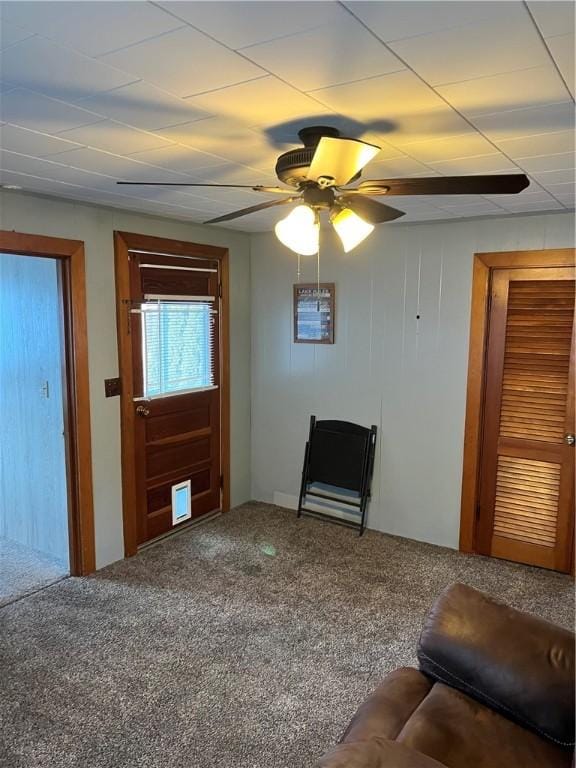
(0, 536, 69, 606)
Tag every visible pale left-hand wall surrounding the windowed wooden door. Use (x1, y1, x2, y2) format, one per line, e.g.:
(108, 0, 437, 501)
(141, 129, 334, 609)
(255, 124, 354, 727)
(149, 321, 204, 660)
(0, 191, 250, 568)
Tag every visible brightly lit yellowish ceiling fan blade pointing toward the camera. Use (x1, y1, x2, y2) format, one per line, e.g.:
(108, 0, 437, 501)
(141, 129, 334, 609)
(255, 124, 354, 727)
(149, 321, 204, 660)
(306, 136, 380, 186)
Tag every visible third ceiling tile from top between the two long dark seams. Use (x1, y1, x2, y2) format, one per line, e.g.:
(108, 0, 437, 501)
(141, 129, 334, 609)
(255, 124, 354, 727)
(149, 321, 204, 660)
(436, 62, 569, 117)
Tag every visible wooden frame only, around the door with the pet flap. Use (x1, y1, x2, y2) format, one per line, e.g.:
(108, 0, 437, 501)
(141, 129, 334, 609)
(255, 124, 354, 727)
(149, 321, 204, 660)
(114, 231, 230, 557)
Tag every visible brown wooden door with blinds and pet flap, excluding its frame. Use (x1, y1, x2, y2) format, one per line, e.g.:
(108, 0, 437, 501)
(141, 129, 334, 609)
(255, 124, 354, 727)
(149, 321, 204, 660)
(129, 251, 222, 544)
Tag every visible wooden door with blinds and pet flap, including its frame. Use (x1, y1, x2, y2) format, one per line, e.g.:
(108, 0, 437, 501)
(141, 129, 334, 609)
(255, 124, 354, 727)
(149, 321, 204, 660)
(115, 232, 230, 557)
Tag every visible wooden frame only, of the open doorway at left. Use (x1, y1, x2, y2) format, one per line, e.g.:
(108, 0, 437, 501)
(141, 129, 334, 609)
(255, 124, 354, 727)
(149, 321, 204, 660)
(0, 230, 96, 576)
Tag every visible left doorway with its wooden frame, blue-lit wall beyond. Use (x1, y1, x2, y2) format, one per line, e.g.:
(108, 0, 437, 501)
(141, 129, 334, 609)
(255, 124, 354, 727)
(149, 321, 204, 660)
(0, 232, 95, 604)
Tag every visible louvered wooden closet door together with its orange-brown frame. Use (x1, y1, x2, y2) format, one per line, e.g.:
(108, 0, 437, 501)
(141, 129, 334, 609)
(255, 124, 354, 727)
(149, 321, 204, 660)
(460, 249, 576, 573)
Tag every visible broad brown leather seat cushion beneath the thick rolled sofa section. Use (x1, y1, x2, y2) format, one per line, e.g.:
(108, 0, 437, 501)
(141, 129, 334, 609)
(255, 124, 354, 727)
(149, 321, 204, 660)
(398, 683, 572, 768)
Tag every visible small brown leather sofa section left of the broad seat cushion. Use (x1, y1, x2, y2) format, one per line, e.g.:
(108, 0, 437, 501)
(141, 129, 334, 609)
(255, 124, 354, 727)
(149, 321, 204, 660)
(341, 667, 432, 741)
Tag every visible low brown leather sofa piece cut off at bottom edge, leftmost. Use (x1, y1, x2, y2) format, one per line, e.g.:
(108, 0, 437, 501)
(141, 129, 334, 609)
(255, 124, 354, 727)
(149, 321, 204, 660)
(316, 738, 445, 768)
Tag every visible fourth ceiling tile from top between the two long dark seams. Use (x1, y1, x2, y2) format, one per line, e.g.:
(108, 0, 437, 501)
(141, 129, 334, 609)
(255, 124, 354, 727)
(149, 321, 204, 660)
(472, 101, 574, 141)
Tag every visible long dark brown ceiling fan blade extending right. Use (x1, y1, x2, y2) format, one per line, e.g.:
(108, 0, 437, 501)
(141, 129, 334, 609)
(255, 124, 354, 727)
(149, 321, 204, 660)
(358, 173, 530, 195)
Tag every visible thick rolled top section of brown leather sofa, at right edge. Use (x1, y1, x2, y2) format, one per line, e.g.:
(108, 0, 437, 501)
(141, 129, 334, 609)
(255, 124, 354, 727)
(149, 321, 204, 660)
(418, 584, 574, 747)
